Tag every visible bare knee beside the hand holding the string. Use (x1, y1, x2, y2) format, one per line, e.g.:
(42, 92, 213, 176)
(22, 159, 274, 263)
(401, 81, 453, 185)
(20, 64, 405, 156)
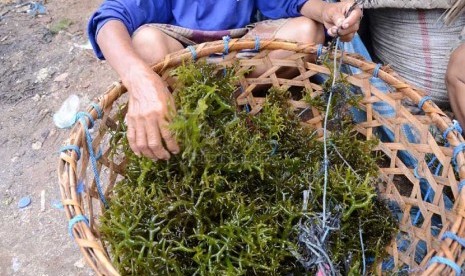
(277, 16, 325, 44)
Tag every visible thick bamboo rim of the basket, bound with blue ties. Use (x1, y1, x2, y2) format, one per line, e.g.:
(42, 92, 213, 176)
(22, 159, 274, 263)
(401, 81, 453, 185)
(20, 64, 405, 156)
(58, 39, 465, 275)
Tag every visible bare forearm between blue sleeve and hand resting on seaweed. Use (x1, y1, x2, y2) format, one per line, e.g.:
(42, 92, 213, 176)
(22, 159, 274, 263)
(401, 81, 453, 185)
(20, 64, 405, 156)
(97, 20, 148, 85)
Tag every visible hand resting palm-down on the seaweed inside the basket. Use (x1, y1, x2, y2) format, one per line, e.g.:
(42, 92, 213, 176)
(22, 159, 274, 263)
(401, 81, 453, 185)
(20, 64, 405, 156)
(123, 66, 179, 160)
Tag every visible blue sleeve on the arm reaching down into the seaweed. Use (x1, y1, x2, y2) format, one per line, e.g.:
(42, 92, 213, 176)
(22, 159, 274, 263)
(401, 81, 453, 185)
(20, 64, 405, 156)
(87, 0, 172, 59)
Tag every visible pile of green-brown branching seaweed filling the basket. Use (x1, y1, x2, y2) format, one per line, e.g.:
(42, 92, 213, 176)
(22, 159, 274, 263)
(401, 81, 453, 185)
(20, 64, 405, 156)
(100, 63, 396, 275)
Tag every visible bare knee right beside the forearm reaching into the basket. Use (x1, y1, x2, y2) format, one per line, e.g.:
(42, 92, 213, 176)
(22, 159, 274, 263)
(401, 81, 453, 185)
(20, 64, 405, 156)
(132, 26, 179, 64)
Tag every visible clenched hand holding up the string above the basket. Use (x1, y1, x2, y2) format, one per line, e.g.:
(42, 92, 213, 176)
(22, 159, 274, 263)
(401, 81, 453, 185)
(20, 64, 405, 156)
(322, 1, 363, 42)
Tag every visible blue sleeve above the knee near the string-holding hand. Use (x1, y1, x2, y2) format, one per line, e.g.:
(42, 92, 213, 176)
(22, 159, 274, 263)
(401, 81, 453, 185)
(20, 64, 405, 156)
(256, 0, 307, 19)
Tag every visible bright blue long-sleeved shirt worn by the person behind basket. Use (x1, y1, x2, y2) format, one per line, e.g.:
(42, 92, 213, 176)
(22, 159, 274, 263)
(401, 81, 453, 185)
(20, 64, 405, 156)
(87, 0, 307, 59)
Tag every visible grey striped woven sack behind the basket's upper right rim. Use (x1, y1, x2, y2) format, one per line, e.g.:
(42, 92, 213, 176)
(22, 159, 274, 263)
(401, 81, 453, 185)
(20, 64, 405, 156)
(367, 9, 465, 108)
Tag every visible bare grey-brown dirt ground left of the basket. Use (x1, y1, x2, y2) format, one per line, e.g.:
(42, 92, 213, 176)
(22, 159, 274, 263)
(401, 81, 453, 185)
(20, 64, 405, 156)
(0, 0, 117, 275)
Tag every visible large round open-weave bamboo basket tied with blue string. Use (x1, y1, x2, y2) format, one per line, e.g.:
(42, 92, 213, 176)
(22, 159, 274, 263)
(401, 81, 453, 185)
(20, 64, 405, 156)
(58, 39, 465, 275)
